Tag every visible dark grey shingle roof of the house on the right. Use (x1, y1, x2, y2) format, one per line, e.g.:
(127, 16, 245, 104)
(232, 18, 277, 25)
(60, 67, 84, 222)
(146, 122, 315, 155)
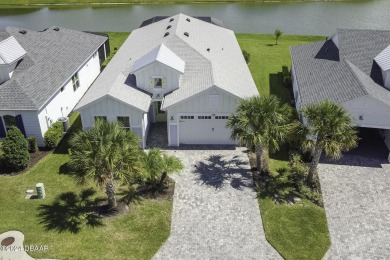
(290, 29, 390, 106)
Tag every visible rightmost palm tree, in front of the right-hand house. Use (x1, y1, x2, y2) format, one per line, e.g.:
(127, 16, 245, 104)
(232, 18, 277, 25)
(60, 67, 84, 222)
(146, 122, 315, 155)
(302, 100, 358, 184)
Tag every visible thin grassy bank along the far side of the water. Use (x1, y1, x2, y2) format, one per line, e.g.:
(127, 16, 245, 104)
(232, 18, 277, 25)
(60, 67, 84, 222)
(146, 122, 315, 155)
(0, 0, 359, 7)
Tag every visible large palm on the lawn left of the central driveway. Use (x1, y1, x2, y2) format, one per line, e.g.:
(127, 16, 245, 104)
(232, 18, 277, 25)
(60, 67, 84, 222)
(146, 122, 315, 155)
(69, 120, 140, 208)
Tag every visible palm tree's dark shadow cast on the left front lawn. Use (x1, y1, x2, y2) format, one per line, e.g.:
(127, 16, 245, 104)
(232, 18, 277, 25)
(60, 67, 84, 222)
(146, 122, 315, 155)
(38, 189, 103, 234)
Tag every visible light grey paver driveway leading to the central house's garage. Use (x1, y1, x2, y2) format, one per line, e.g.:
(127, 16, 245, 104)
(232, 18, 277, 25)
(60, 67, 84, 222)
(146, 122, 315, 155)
(154, 148, 282, 260)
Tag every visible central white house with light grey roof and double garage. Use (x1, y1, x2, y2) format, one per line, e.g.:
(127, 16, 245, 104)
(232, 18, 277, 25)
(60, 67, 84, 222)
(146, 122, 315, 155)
(76, 14, 258, 147)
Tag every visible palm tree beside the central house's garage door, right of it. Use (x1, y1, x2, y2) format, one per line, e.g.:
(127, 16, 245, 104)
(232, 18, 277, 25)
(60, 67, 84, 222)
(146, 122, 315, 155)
(226, 95, 293, 172)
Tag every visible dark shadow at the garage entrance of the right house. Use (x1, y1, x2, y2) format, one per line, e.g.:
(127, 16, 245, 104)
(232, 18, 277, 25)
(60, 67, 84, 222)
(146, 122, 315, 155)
(320, 127, 389, 168)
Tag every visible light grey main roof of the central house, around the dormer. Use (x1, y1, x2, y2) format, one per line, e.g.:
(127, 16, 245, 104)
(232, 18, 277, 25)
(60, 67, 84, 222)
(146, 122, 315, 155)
(76, 14, 258, 112)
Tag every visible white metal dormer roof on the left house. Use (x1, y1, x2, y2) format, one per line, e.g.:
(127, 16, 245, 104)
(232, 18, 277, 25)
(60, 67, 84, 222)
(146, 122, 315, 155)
(0, 36, 27, 64)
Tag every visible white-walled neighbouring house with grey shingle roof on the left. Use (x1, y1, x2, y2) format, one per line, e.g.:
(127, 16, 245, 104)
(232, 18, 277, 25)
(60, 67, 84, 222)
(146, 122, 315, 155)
(0, 27, 108, 146)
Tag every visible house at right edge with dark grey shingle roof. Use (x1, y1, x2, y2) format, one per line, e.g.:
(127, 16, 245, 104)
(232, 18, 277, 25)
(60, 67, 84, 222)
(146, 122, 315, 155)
(291, 29, 390, 154)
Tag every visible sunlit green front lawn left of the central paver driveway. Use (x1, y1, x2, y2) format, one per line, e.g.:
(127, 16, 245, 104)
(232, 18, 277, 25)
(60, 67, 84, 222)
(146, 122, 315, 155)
(0, 112, 172, 259)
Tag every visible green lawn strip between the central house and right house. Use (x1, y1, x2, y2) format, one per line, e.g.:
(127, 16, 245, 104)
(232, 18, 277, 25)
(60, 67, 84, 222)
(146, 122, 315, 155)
(237, 34, 330, 260)
